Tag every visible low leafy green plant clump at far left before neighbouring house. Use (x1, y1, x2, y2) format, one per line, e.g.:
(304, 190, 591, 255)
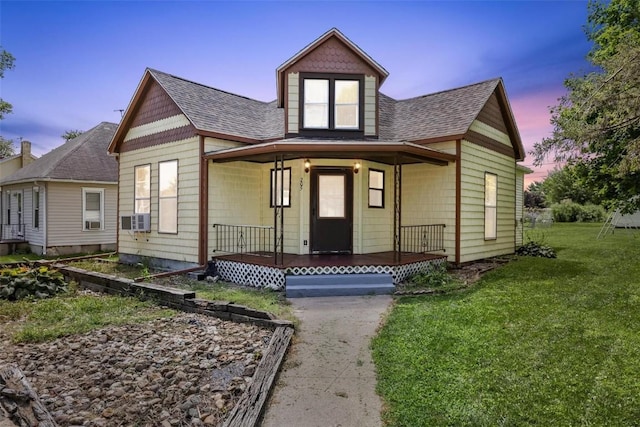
(0, 266, 67, 301)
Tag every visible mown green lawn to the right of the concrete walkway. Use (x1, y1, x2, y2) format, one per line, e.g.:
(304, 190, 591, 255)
(372, 224, 640, 427)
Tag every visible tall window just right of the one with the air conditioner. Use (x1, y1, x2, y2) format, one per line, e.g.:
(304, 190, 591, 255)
(158, 160, 178, 233)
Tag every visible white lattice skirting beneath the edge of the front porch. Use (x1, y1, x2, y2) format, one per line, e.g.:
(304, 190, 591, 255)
(216, 257, 447, 290)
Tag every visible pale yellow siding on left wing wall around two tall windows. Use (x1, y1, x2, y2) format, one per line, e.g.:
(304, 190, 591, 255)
(118, 137, 200, 263)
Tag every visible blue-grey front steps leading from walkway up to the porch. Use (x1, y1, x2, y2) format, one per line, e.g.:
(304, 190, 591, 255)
(285, 273, 396, 298)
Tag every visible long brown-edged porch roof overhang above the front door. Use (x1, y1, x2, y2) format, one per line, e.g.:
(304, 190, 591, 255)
(205, 139, 456, 166)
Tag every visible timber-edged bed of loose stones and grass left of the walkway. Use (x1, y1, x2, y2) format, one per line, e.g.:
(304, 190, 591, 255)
(0, 290, 273, 426)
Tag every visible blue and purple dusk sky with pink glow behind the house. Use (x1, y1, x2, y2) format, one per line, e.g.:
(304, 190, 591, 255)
(0, 0, 591, 181)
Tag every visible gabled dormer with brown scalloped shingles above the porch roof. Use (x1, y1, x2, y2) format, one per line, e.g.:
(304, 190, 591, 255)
(277, 28, 389, 139)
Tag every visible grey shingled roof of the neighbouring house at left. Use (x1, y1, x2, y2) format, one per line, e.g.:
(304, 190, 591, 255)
(1, 122, 118, 185)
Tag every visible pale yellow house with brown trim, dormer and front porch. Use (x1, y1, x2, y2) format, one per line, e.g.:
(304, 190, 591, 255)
(109, 29, 525, 295)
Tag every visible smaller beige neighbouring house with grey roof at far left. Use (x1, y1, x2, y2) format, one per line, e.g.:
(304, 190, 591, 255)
(0, 122, 118, 255)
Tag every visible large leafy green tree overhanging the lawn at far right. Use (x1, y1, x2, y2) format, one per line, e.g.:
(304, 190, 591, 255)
(532, 0, 640, 211)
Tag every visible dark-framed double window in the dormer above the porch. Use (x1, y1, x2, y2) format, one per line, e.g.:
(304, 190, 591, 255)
(300, 74, 364, 137)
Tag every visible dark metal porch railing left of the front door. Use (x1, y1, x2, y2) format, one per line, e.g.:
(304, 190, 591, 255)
(213, 224, 274, 257)
